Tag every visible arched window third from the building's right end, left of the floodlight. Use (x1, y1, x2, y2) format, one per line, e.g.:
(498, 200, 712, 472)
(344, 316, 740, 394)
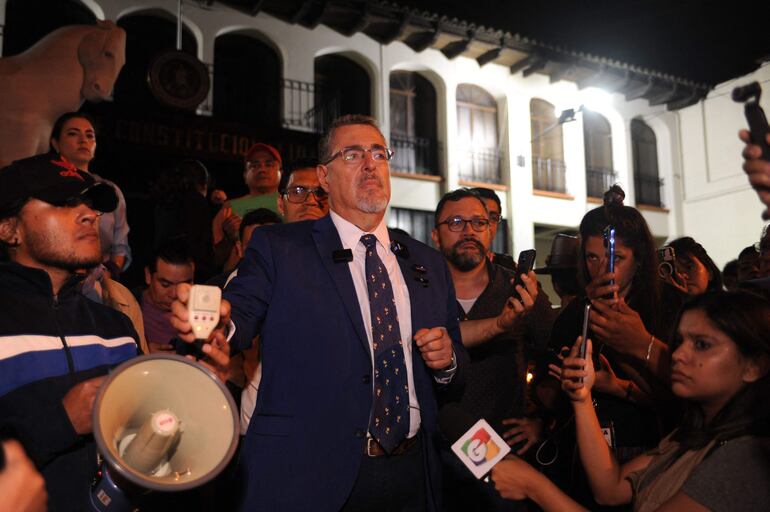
(529, 98, 567, 192)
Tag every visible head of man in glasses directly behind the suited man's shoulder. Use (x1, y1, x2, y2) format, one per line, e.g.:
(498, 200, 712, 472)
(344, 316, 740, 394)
(278, 159, 329, 222)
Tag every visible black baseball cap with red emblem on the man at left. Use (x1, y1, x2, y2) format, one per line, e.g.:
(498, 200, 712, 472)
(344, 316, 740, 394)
(0, 153, 118, 215)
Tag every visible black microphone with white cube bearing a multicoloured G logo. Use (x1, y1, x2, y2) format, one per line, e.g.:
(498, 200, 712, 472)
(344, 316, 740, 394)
(438, 404, 511, 482)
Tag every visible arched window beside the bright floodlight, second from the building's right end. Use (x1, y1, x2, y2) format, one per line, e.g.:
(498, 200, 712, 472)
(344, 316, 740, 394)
(583, 110, 615, 197)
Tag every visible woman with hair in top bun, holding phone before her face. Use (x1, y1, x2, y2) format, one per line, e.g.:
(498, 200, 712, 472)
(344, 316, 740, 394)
(538, 185, 685, 507)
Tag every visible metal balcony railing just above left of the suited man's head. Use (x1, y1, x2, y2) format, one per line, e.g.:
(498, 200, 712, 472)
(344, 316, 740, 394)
(283, 79, 340, 133)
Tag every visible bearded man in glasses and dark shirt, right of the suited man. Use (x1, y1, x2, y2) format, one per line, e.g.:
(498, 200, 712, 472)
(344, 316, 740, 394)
(432, 189, 552, 511)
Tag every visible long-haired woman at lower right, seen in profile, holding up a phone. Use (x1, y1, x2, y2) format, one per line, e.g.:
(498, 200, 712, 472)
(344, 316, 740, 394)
(492, 291, 770, 512)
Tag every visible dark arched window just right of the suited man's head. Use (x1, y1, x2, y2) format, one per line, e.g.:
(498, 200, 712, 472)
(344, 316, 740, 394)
(390, 71, 440, 175)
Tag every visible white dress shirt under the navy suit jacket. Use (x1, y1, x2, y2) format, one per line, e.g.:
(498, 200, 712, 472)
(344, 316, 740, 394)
(329, 211, 420, 437)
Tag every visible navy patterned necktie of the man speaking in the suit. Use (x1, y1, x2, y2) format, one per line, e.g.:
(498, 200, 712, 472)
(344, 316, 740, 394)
(361, 235, 409, 453)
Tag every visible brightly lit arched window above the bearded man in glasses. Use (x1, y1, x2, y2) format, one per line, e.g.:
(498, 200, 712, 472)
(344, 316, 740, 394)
(457, 84, 502, 183)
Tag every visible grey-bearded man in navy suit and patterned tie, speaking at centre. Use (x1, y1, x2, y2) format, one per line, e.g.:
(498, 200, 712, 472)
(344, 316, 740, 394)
(174, 116, 467, 511)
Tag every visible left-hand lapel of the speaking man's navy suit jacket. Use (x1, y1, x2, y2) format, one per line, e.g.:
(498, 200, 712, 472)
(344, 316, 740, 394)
(313, 215, 371, 354)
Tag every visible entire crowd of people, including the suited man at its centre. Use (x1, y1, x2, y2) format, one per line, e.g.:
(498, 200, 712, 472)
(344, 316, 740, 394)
(0, 113, 770, 511)
